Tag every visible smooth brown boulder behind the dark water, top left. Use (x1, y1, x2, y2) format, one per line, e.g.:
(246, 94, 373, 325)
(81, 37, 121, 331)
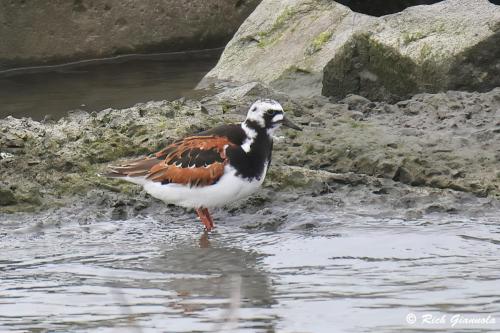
(0, 0, 260, 69)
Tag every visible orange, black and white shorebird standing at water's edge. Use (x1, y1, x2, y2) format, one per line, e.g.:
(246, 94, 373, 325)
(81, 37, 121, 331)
(106, 99, 302, 232)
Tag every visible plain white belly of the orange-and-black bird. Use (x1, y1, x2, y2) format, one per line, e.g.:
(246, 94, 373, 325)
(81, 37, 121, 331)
(138, 165, 267, 208)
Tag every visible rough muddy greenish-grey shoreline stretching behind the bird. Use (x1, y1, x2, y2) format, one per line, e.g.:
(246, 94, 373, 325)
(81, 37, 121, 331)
(0, 83, 500, 223)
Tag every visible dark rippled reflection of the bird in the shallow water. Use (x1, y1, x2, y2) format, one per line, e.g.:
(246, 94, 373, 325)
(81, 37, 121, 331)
(148, 232, 277, 331)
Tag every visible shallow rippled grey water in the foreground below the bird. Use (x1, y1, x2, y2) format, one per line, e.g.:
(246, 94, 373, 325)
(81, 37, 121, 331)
(0, 206, 500, 332)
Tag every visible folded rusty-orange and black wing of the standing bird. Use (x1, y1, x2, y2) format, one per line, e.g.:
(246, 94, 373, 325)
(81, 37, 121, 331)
(107, 135, 234, 186)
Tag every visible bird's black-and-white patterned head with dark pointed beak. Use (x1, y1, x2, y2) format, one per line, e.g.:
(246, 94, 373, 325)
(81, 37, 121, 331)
(245, 99, 302, 135)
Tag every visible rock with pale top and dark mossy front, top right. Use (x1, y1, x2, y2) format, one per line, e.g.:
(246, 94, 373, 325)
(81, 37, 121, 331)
(322, 0, 500, 101)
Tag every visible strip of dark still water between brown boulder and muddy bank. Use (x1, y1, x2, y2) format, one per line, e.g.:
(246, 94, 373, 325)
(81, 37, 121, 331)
(0, 50, 220, 120)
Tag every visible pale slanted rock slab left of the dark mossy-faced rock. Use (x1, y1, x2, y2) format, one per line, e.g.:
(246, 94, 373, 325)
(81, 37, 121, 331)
(204, 0, 372, 96)
